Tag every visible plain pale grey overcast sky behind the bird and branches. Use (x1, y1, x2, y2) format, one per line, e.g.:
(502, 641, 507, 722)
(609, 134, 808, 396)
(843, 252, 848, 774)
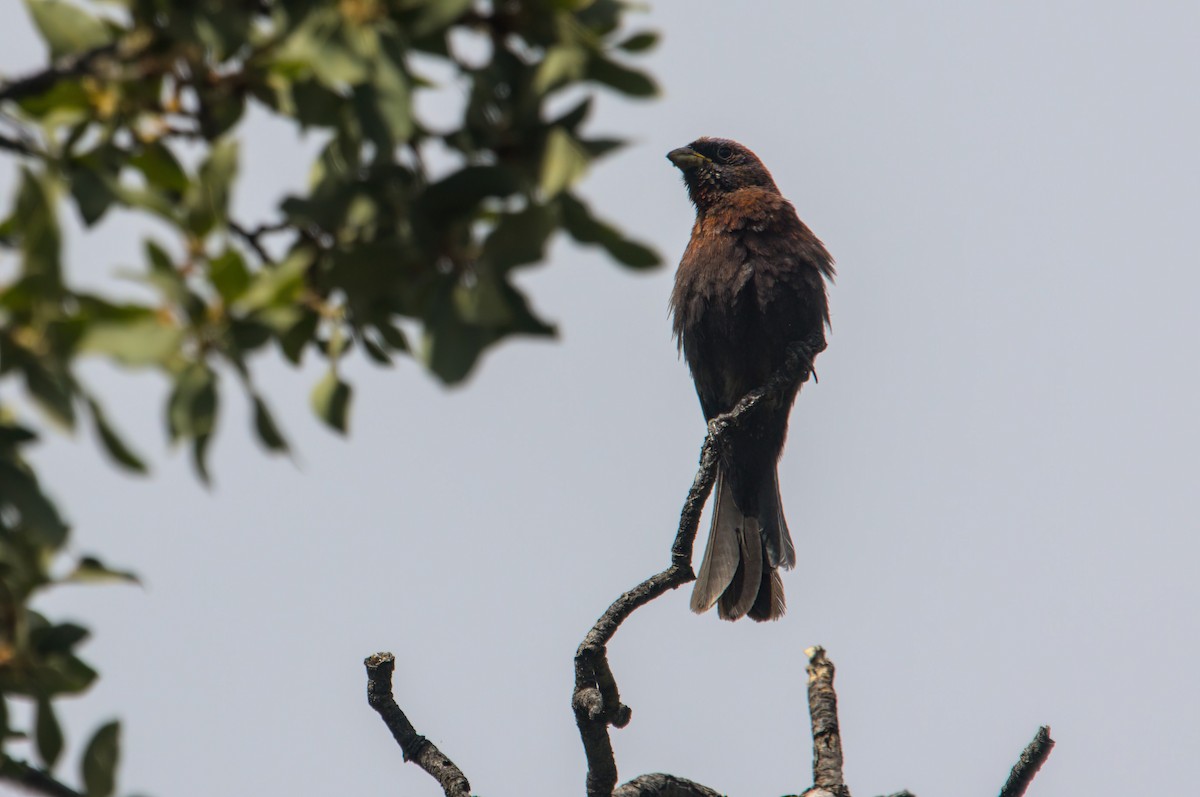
(0, 0, 1200, 797)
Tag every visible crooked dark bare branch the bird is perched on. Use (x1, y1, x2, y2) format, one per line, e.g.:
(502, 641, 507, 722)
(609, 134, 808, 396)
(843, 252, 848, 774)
(571, 336, 826, 797)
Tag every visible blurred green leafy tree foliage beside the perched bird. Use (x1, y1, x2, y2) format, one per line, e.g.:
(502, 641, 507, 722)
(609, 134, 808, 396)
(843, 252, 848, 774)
(0, 0, 658, 797)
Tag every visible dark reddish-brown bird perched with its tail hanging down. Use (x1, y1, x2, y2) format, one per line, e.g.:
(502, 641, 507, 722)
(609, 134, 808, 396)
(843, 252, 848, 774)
(667, 138, 834, 621)
